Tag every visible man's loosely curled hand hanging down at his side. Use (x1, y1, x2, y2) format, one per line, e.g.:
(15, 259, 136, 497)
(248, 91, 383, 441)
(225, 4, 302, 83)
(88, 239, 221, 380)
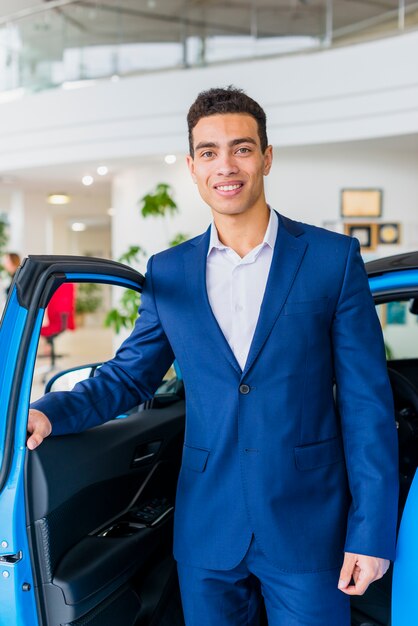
(338, 552, 389, 596)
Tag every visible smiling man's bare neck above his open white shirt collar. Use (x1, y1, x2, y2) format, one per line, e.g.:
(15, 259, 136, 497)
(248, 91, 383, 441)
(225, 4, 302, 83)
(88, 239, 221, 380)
(214, 205, 270, 258)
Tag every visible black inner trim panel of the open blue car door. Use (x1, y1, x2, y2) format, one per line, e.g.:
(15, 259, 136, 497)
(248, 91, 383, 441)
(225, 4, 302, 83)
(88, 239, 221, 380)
(26, 401, 184, 624)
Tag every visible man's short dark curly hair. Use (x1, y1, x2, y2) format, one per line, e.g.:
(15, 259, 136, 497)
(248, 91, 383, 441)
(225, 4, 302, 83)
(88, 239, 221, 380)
(187, 85, 268, 157)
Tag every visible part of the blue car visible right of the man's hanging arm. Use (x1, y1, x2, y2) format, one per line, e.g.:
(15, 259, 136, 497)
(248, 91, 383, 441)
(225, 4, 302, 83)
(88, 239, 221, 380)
(365, 252, 418, 626)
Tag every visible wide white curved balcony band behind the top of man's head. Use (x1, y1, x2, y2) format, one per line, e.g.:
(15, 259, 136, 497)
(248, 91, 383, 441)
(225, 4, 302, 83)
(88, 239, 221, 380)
(0, 32, 418, 171)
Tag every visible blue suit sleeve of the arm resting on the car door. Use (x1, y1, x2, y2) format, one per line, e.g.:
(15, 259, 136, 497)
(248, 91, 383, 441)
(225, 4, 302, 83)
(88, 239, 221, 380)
(31, 257, 174, 435)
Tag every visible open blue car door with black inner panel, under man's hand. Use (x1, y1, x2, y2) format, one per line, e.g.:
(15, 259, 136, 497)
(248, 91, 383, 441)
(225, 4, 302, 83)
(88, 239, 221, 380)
(0, 256, 184, 626)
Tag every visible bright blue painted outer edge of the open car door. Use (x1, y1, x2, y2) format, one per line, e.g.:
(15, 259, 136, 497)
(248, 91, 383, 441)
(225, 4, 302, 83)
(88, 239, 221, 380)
(0, 288, 43, 626)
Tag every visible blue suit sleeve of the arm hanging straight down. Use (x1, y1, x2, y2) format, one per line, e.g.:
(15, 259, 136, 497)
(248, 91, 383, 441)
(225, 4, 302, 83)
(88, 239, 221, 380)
(332, 239, 398, 559)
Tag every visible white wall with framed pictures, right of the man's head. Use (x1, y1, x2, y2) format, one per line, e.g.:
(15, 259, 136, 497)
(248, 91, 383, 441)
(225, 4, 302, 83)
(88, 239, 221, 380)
(266, 136, 418, 258)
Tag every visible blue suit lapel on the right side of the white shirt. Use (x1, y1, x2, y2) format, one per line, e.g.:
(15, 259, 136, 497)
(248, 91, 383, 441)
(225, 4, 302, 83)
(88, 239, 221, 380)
(243, 215, 307, 376)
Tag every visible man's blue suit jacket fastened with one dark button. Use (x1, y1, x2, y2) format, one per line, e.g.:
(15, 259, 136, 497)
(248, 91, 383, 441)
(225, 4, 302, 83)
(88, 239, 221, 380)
(33, 216, 398, 572)
